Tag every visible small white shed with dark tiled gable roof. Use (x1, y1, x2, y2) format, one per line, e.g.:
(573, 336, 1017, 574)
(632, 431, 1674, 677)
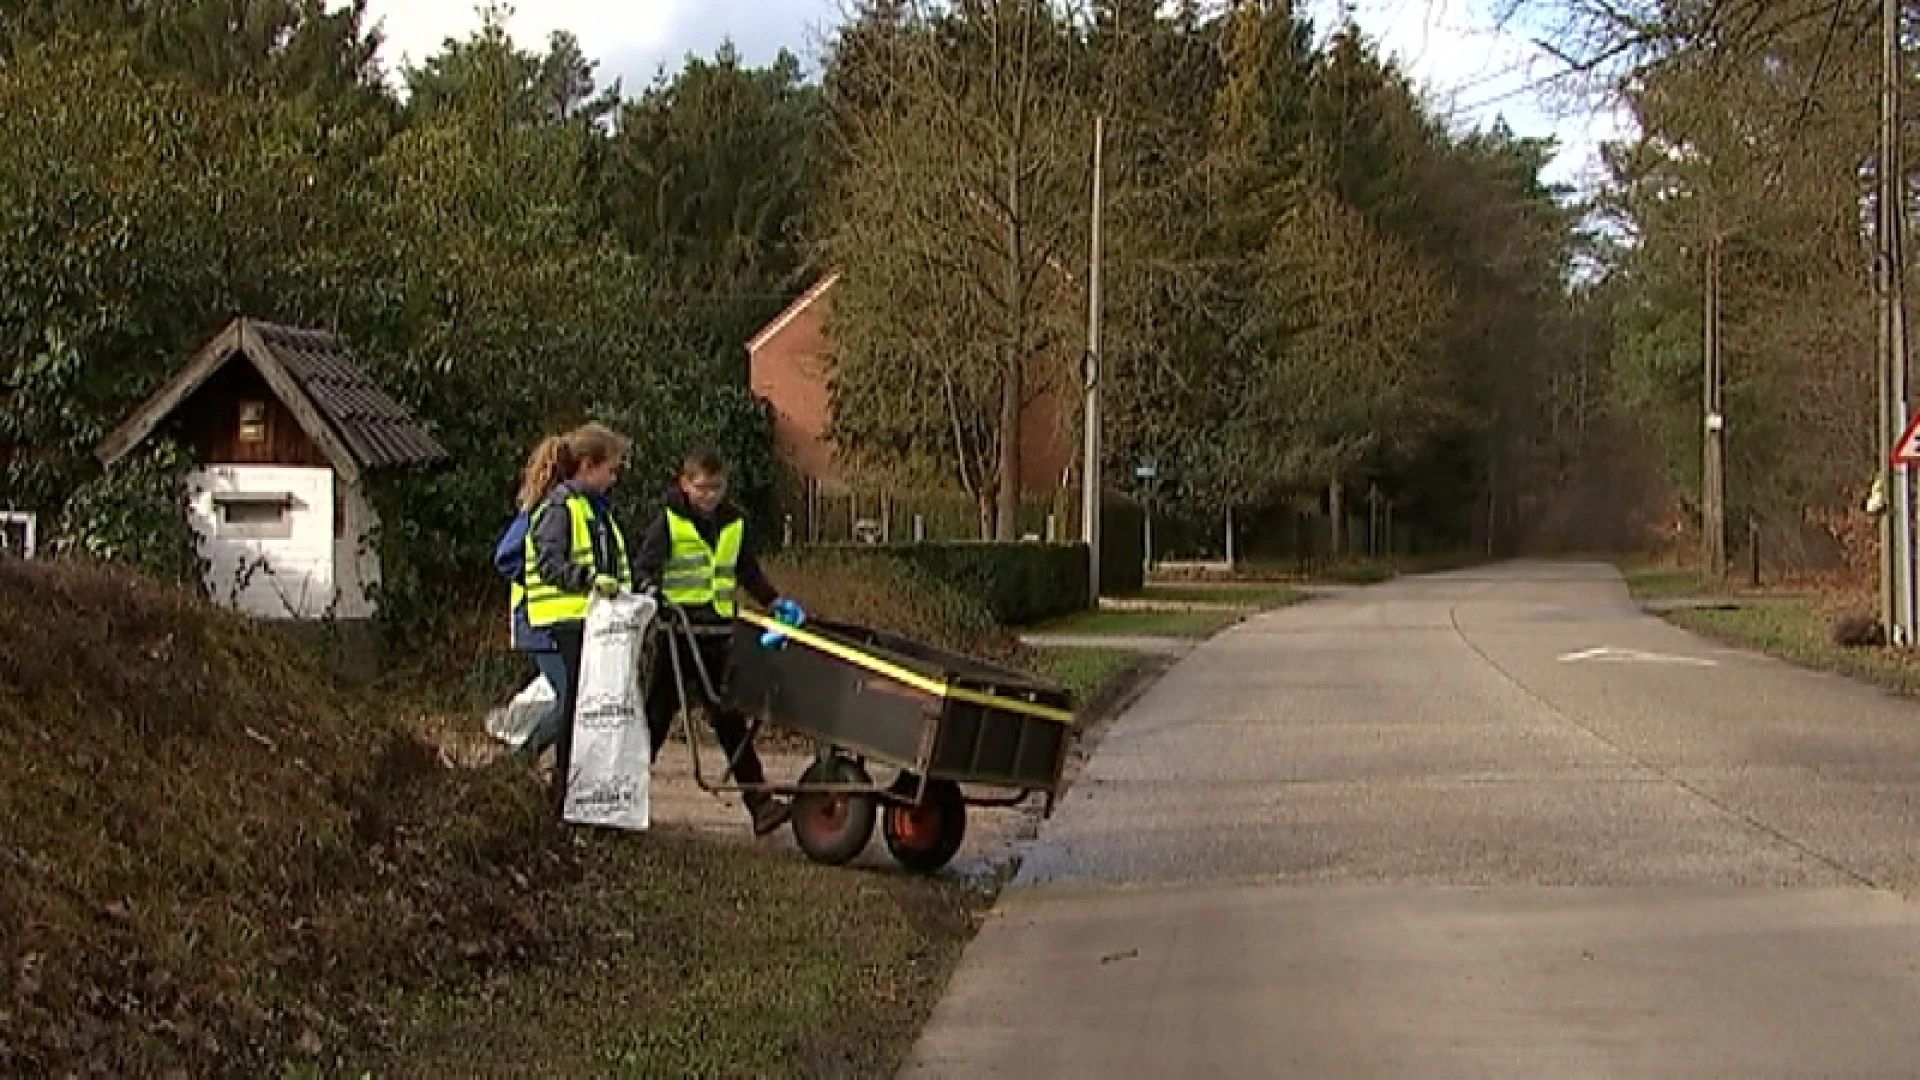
(96, 319, 445, 619)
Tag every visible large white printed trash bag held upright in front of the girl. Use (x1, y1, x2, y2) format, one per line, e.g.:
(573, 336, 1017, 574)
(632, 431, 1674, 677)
(564, 592, 659, 830)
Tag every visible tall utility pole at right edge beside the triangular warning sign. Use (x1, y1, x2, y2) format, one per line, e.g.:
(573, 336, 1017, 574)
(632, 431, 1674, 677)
(1876, 0, 1914, 646)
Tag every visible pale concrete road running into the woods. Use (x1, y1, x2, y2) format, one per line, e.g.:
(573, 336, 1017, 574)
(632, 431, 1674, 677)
(904, 563, 1920, 1078)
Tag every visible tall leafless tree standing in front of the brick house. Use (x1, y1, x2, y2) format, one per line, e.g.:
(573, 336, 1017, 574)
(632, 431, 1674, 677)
(822, 0, 1092, 540)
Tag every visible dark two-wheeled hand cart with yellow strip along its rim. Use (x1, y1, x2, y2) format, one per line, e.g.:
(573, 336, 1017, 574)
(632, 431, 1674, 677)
(655, 601, 1077, 872)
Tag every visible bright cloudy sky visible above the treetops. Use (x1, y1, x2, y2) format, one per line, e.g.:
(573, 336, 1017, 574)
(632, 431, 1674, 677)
(353, 0, 1624, 188)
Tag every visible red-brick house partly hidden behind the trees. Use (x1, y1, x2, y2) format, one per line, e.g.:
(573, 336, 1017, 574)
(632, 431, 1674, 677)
(747, 271, 1079, 496)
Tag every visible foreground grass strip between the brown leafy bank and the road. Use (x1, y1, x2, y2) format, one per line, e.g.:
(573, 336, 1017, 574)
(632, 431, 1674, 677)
(359, 828, 989, 1078)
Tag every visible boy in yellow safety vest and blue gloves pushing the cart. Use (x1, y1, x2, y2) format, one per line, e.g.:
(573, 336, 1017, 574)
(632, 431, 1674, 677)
(634, 450, 803, 836)
